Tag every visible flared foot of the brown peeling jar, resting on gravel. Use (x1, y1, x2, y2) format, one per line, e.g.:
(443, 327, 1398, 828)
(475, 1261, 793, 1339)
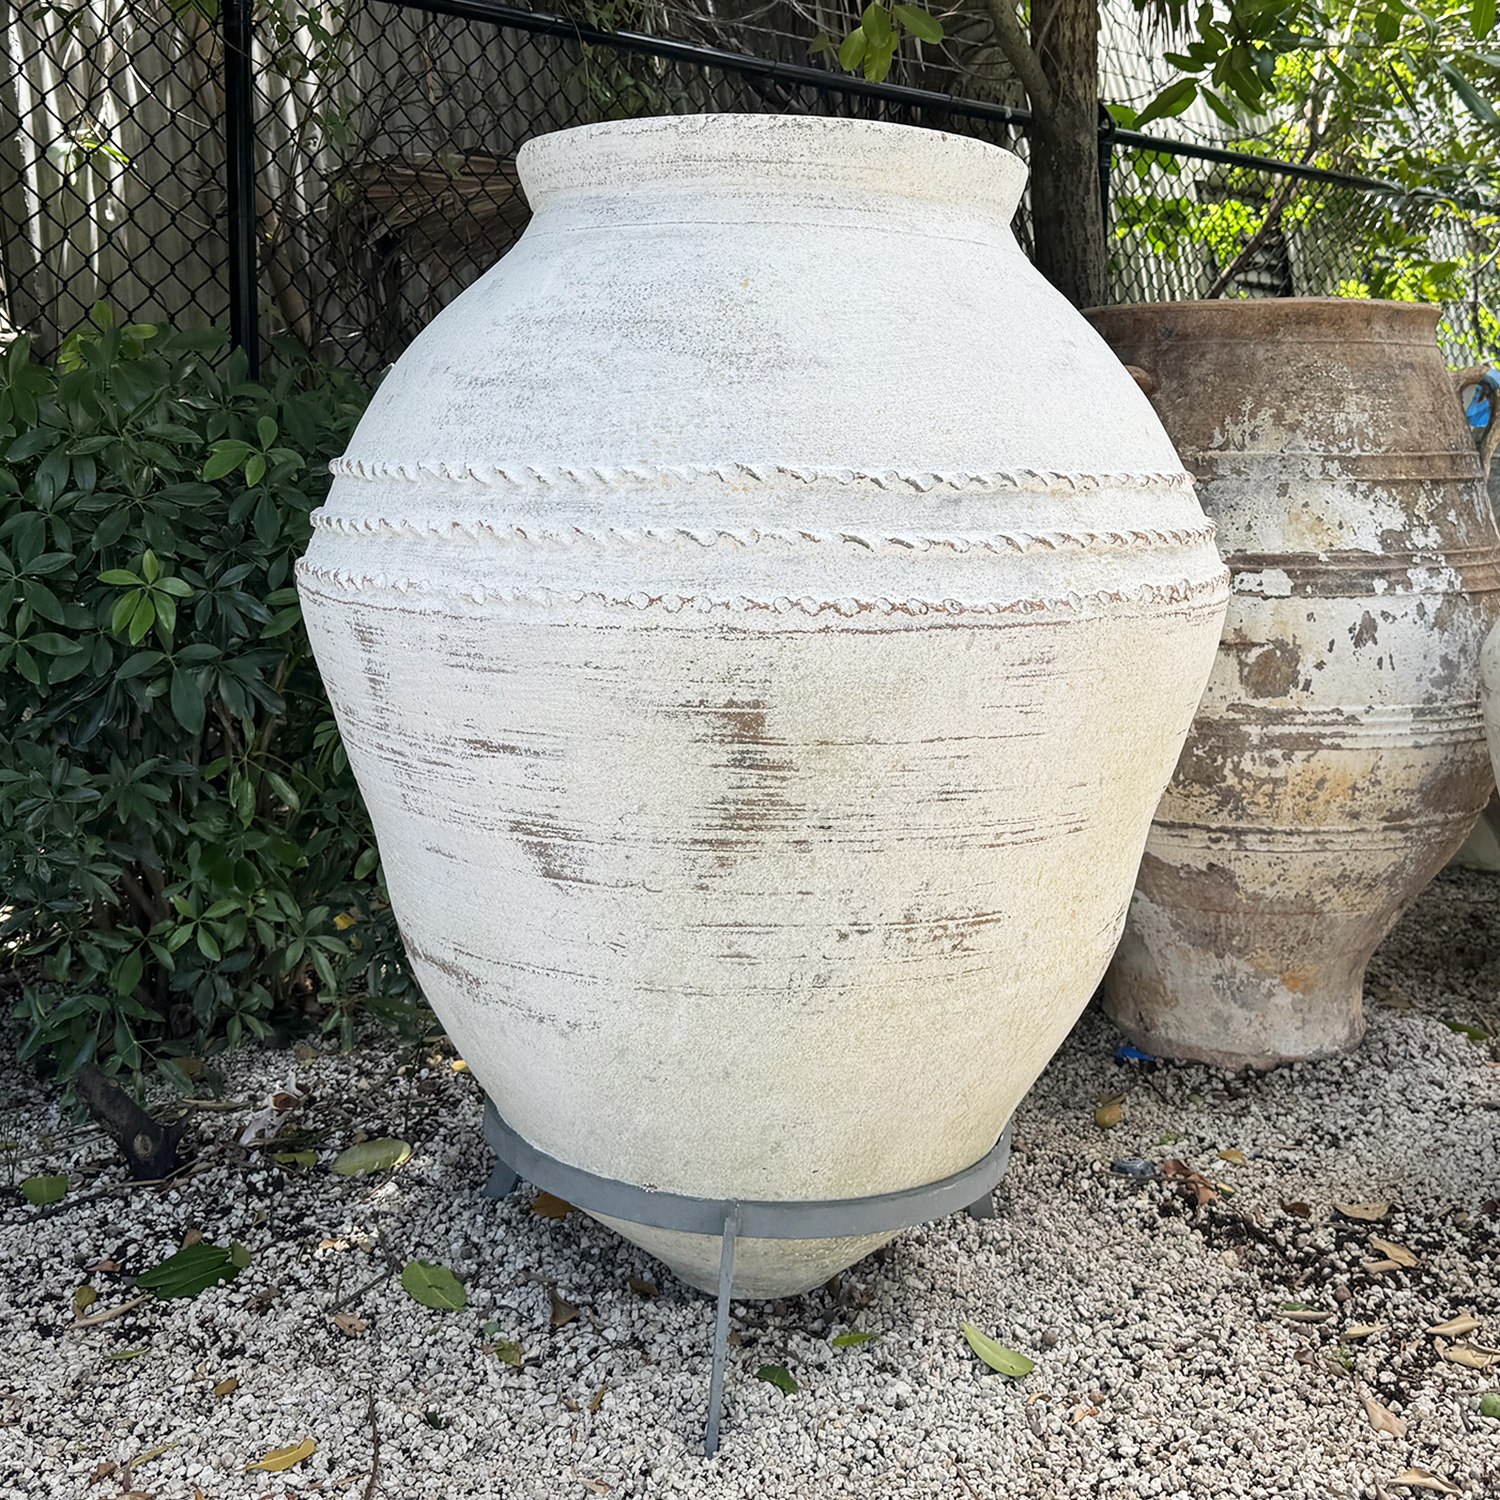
(1104, 912, 1370, 1068)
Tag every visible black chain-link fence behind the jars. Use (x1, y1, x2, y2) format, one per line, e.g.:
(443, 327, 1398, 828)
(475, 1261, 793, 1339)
(0, 0, 1500, 374)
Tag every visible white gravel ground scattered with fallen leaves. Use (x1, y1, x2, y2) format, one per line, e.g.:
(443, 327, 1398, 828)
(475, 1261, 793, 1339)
(0, 875, 1500, 1500)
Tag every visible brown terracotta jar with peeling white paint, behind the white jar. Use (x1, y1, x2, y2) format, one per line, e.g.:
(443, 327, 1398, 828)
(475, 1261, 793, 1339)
(1088, 299, 1500, 1067)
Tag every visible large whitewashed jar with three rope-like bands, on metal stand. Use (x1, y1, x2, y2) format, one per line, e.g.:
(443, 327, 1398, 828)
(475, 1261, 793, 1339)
(299, 116, 1229, 1296)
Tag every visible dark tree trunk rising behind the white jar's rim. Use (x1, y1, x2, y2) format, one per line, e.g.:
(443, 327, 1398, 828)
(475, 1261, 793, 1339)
(1031, 0, 1109, 308)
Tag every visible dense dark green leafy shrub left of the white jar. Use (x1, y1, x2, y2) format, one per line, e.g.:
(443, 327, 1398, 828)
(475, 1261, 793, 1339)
(0, 308, 416, 1086)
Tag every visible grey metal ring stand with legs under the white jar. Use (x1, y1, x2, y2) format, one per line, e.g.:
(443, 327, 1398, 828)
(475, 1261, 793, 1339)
(485, 1097, 1011, 1457)
